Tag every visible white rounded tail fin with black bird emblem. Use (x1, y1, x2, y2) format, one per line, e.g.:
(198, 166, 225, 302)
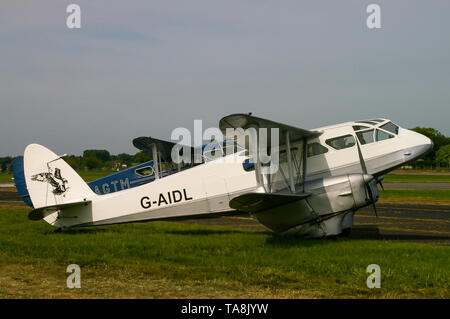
(23, 144, 97, 209)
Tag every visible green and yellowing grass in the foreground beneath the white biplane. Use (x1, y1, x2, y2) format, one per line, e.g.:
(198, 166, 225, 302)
(0, 208, 450, 298)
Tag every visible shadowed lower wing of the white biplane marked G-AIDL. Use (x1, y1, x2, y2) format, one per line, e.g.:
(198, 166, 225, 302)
(230, 193, 311, 213)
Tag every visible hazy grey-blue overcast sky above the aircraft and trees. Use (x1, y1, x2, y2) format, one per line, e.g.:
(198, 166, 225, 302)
(0, 0, 450, 156)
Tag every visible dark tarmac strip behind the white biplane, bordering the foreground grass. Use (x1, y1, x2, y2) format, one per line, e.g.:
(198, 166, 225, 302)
(0, 188, 450, 246)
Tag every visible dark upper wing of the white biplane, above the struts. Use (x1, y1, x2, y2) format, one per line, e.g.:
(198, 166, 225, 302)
(219, 114, 322, 146)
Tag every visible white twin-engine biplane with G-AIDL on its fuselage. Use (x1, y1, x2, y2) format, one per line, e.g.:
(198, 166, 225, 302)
(24, 114, 432, 238)
